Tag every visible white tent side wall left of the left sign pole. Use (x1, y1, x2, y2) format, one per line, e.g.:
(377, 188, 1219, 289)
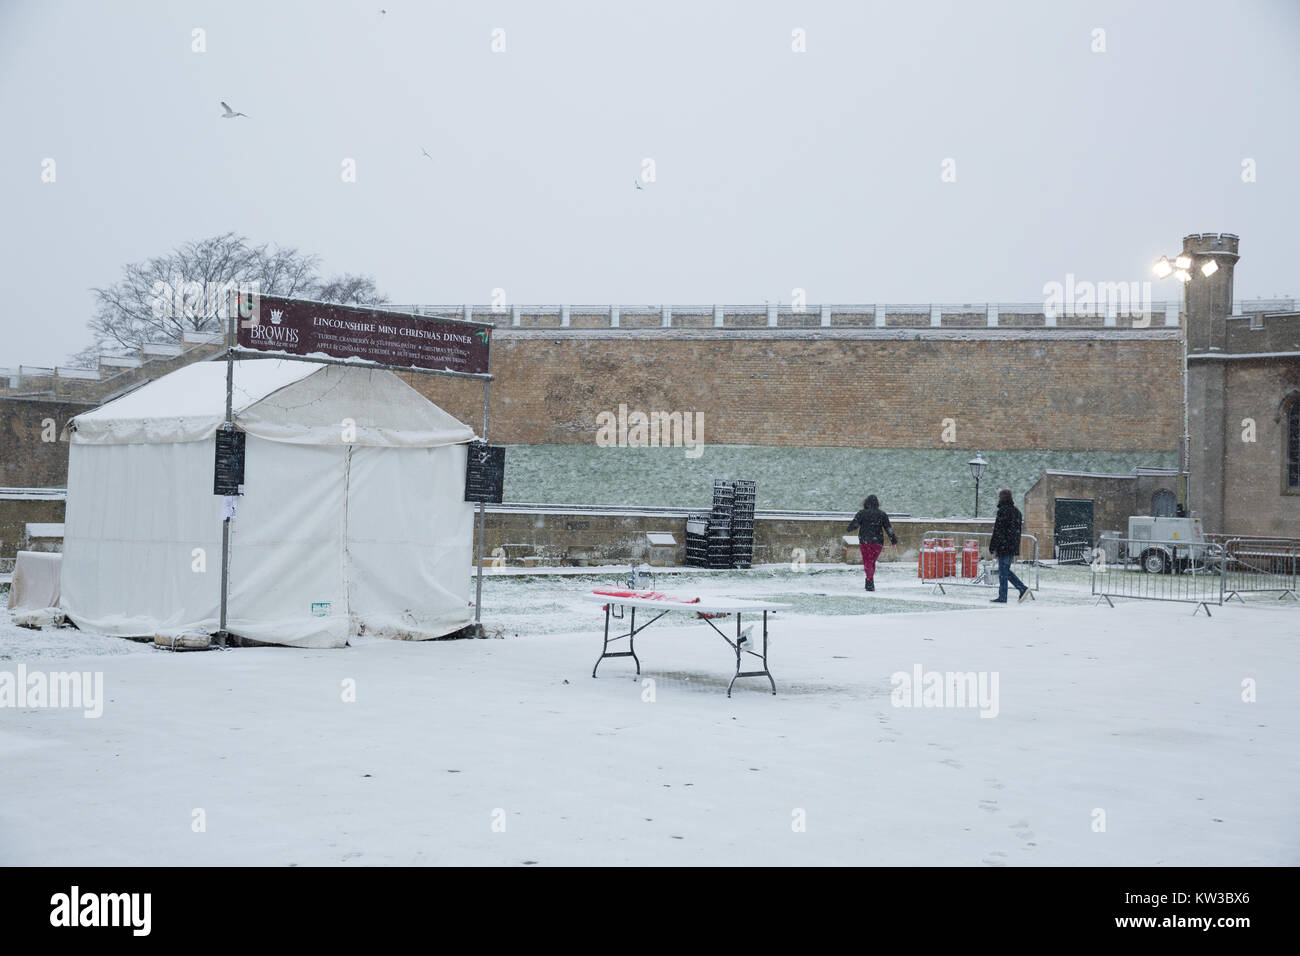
(60, 441, 221, 637)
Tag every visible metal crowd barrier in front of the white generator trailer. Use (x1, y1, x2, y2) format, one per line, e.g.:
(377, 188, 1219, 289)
(1092, 535, 1226, 617)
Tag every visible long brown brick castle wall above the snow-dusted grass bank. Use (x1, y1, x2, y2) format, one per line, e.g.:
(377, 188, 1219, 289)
(408, 330, 1182, 451)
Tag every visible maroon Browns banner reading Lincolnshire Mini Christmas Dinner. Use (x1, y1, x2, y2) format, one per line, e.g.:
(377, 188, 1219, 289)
(238, 295, 493, 375)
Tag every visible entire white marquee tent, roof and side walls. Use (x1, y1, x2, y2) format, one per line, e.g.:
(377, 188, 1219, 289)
(60, 359, 475, 648)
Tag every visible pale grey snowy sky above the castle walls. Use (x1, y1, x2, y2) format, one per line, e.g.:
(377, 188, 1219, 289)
(0, 0, 1300, 365)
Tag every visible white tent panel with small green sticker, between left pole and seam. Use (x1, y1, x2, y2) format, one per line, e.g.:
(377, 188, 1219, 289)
(226, 434, 351, 648)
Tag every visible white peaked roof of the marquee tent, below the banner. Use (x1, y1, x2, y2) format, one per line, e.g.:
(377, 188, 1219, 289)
(72, 359, 475, 447)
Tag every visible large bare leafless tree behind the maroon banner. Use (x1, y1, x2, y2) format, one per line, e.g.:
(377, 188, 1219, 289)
(70, 233, 387, 365)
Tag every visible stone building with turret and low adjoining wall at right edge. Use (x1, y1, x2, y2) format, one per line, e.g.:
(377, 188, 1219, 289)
(1026, 233, 1300, 555)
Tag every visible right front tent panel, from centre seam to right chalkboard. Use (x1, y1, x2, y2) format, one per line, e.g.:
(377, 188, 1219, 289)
(347, 445, 475, 640)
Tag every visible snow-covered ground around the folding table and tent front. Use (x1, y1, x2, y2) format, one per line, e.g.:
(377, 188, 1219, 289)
(0, 564, 1300, 866)
